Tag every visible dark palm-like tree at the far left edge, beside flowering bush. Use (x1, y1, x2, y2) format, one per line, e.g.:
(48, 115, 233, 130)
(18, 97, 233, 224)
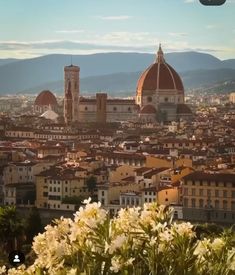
(0, 206, 24, 252)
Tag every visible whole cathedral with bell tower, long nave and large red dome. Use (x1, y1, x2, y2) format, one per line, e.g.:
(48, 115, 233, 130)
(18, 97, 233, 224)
(61, 45, 192, 124)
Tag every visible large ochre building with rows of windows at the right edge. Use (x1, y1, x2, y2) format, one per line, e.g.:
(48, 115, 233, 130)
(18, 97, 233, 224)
(182, 174, 235, 224)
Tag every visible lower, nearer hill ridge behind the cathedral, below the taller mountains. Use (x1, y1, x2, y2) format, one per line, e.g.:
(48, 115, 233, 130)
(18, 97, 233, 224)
(18, 69, 235, 96)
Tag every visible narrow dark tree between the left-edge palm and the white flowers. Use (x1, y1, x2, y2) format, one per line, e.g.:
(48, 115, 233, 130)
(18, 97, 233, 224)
(25, 207, 43, 243)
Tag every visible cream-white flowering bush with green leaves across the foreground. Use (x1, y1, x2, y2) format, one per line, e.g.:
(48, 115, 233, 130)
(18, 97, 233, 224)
(0, 200, 235, 275)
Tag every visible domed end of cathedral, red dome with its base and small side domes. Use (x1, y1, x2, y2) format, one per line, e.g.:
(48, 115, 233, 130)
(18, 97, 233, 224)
(136, 45, 192, 122)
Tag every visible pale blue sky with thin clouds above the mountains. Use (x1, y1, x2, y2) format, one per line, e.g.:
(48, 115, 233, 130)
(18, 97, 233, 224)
(0, 0, 235, 59)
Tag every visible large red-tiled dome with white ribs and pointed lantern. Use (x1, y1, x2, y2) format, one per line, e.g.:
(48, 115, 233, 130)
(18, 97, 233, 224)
(136, 45, 184, 96)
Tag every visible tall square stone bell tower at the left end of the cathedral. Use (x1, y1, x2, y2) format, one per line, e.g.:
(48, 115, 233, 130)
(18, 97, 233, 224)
(64, 64, 80, 123)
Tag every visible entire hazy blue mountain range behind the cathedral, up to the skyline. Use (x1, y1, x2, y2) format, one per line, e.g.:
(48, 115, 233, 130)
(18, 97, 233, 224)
(0, 52, 235, 94)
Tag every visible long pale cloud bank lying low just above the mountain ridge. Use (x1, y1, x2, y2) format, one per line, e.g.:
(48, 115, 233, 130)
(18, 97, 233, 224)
(0, 37, 235, 58)
